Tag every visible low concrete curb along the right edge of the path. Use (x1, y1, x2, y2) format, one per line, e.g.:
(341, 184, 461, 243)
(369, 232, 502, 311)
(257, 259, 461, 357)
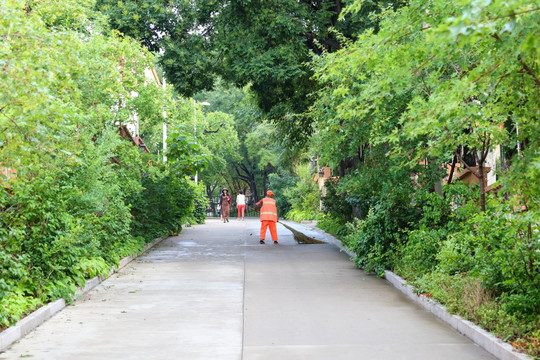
(280, 220, 531, 360)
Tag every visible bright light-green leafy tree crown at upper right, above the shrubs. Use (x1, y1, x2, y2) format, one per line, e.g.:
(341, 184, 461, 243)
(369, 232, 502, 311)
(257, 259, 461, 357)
(314, 0, 540, 209)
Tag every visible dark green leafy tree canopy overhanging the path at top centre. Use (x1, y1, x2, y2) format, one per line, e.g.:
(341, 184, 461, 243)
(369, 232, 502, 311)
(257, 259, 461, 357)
(97, 0, 403, 140)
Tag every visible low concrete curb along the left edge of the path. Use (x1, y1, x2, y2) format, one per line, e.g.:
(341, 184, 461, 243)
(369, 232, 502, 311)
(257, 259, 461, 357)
(0, 236, 167, 353)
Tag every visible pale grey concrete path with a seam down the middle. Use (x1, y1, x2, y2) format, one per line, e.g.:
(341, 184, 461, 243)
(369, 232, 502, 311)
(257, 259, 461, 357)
(0, 219, 494, 360)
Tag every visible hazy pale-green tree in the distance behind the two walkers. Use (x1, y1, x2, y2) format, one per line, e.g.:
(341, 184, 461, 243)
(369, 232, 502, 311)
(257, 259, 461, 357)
(194, 82, 289, 204)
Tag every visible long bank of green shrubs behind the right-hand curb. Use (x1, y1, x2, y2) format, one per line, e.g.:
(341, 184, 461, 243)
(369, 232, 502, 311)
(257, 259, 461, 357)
(319, 177, 540, 356)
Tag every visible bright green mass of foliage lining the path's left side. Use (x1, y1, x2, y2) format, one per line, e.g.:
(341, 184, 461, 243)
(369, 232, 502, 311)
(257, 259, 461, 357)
(0, 0, 204, 329)
